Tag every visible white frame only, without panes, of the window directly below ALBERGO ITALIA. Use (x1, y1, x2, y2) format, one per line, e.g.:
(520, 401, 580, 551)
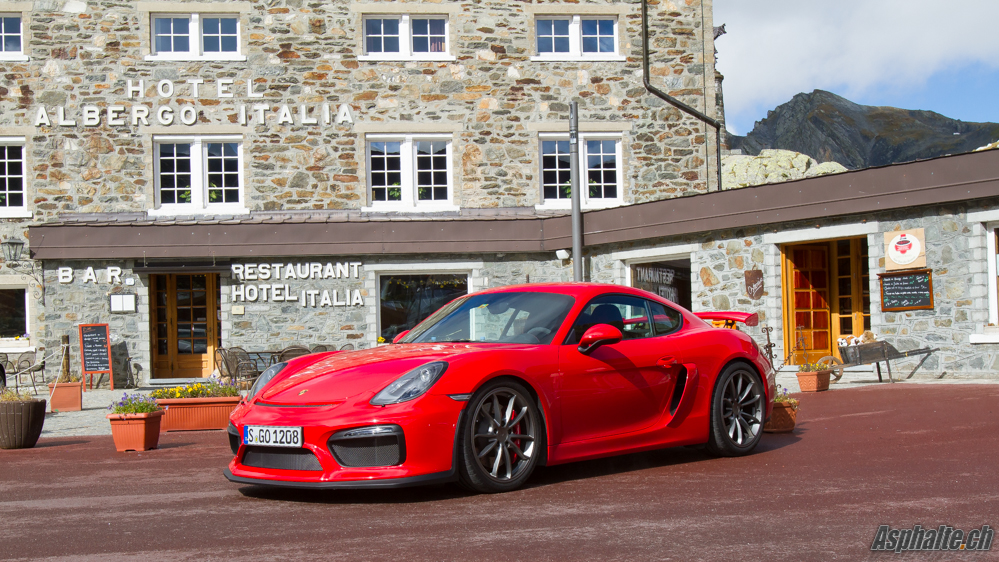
(149, 135, 250, 216)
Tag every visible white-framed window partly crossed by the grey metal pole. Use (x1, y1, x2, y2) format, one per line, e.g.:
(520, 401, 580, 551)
(541, 134, 622, 208)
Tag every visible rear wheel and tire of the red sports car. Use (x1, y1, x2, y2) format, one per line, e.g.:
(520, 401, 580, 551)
(707, 363, 766, 457)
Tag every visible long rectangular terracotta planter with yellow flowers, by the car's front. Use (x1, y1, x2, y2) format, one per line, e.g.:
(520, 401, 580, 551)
(150, 377, 241, 431)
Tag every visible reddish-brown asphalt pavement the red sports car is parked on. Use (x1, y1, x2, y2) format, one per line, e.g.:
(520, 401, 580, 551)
(0, 383, 999, 560)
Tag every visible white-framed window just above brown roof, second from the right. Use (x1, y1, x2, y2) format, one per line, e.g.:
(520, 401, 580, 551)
(367, 135, 453, 210)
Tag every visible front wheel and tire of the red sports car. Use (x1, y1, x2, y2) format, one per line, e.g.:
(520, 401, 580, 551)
(458, 379, 545, 493)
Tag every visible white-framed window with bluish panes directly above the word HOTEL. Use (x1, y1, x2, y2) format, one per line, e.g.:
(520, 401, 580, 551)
(149, 14, 246, 60)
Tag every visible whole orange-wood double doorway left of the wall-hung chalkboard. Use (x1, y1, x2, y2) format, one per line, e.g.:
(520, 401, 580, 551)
(783, 237, 871, 365)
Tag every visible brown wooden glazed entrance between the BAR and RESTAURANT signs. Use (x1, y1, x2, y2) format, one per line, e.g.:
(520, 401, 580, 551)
(149, 273, 221, 379)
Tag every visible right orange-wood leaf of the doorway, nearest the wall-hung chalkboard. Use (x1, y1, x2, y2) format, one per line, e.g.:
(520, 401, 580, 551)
(829, 238, 871, 350)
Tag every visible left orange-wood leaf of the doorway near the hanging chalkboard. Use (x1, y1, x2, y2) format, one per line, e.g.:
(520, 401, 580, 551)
(784, 243, 832, 365)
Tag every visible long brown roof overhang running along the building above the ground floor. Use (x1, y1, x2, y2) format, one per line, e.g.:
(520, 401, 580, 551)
(29, 150, 999, 260)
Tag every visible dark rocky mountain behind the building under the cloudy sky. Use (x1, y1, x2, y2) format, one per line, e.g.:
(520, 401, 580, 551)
(729, 90, 999, 169)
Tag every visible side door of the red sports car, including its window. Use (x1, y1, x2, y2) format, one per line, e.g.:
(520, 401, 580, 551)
(559, 295, 681, 443)
